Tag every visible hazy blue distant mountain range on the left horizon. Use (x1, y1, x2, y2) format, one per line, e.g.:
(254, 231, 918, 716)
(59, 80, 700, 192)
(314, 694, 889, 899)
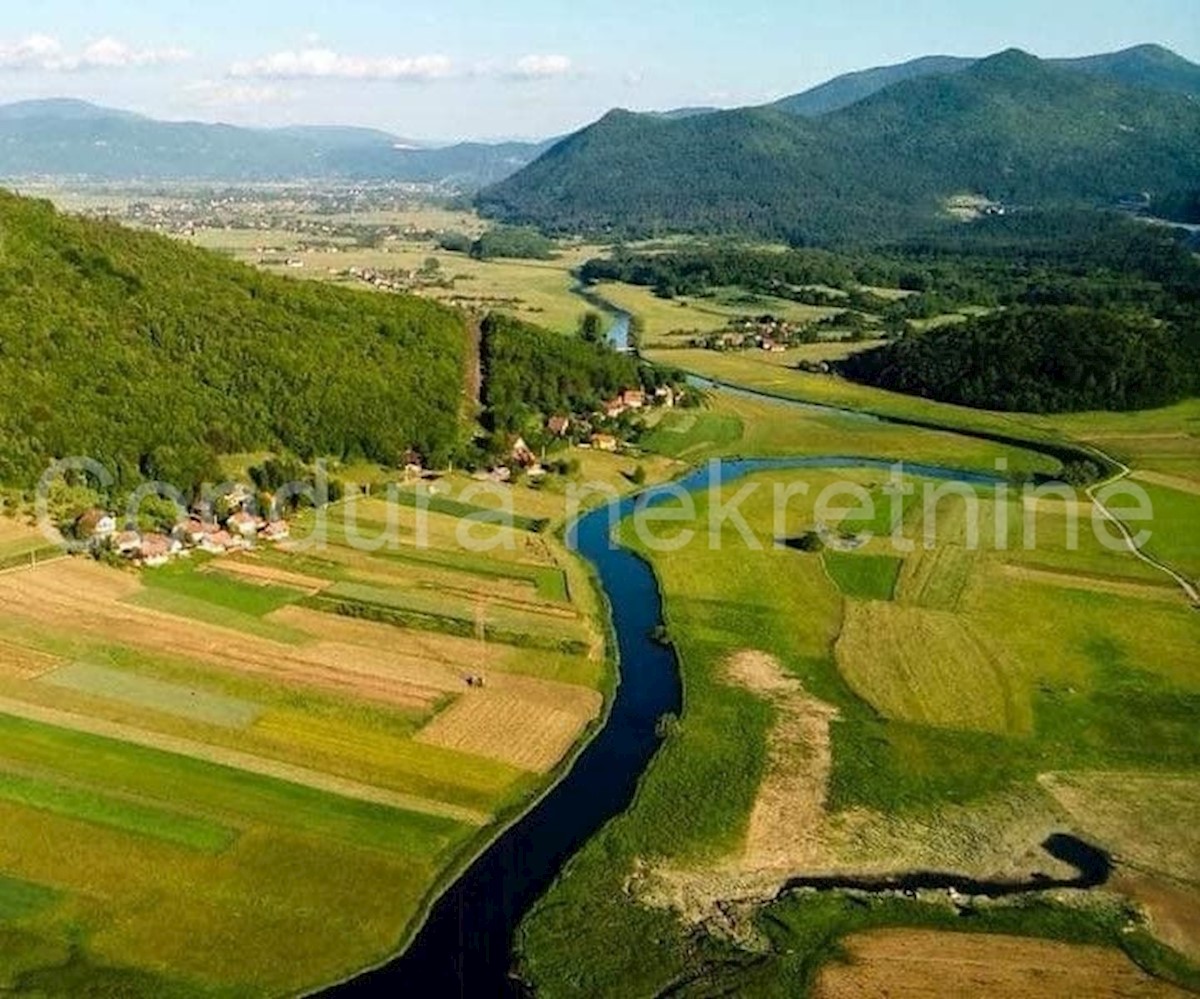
(0, 100, 547, 190)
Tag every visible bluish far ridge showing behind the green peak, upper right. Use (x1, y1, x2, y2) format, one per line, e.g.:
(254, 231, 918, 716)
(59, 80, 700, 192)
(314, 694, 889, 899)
(772, 46, 1200, 118)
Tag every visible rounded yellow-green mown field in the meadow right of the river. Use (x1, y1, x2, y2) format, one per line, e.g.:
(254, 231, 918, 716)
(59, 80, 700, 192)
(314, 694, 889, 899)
(835, 603, 1032, 731)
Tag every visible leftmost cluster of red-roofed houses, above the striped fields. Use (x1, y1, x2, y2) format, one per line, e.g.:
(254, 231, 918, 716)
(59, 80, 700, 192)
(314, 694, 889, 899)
(76, 494, 290, 568)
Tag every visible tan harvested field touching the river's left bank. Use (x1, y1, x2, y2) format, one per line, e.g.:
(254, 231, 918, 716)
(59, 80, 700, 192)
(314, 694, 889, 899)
(416, 677, 602, 773)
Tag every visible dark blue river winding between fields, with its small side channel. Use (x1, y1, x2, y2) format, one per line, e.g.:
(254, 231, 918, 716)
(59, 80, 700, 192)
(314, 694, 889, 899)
(328, 403, 1108, 997)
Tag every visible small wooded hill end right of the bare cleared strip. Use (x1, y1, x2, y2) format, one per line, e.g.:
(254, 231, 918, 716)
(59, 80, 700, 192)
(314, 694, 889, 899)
(482, 313, 642, 433)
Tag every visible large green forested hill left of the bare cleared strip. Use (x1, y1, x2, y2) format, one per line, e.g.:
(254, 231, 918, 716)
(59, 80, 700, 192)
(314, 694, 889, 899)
(0, 192, 467, 489)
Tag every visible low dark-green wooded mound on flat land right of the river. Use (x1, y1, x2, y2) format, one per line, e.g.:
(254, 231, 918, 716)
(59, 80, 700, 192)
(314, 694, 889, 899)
(840, 307, 1200, 413)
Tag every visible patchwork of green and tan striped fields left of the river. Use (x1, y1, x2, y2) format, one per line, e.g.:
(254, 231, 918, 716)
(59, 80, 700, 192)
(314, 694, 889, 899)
(0, 477, 628, 997)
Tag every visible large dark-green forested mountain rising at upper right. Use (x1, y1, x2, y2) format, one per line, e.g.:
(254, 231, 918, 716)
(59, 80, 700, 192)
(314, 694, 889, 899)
(479, 50, 1200, 243)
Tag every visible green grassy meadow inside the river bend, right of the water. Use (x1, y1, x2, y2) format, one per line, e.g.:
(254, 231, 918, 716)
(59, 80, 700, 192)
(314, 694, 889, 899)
(521, 449, 1200, 995)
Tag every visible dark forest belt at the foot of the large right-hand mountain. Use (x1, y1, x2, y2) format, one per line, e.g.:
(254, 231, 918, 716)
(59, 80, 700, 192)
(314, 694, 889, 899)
(581, 210, 1200, 318)
